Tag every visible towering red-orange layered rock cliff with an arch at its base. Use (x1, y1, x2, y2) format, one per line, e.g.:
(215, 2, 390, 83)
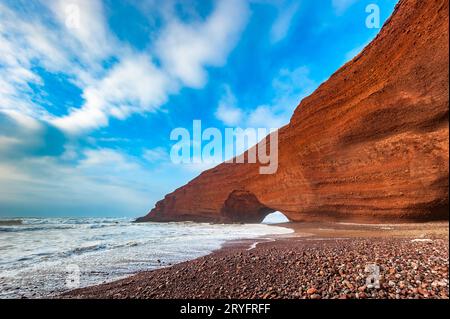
(138, 0, 449, 222)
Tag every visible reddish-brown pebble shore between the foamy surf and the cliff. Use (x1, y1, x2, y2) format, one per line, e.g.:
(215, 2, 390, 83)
(61, 222, 449, 299)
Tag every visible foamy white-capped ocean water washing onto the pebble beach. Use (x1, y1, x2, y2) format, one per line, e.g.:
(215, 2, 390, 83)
(0, 218, 292, 298)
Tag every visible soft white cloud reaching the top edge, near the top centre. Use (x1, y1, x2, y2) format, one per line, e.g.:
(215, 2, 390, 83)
(156, 0, 248, 88)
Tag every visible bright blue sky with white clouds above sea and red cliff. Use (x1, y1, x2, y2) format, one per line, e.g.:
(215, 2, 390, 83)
(0, 0, 396, 216)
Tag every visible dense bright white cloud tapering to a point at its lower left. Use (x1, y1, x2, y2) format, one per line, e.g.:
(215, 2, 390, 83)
(51, 55, 171, 133)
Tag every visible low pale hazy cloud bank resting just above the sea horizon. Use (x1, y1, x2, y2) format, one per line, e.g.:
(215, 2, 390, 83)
(0, 146, 180, 216)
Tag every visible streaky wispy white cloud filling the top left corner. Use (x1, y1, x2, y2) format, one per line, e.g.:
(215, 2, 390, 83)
(0, 2, 103, 125)
